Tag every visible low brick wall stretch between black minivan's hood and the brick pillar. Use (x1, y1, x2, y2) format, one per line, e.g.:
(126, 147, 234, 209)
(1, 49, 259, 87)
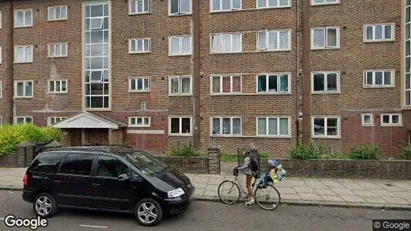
(155, 156, 210, 174)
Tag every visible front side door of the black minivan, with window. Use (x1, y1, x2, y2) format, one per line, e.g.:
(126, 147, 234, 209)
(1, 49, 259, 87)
(93, 155, 131, 210)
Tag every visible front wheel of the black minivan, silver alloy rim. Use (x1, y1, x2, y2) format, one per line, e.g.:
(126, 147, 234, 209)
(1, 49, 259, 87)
(134, 198, 163, 226)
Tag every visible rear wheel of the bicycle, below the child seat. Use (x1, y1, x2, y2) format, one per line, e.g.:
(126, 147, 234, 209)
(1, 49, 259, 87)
(255, 184, 281, 210)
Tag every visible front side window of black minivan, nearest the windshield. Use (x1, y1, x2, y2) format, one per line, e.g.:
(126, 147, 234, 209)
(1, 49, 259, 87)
(97, 155, 128, 178)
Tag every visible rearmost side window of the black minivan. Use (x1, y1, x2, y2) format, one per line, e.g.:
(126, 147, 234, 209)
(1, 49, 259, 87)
(30, 153, 65, 173)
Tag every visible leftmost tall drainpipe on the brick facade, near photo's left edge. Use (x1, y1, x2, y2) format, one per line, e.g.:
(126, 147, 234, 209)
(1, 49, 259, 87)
(5, 1, 15, 124)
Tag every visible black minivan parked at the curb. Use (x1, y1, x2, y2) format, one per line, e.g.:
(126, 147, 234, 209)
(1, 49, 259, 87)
(23, 146, 194, 226)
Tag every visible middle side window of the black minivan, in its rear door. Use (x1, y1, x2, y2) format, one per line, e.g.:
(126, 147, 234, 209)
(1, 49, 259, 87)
(60, 154, 93, 176)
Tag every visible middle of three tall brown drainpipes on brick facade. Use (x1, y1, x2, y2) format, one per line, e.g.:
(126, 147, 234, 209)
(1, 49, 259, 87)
(192, 1, 201, 149)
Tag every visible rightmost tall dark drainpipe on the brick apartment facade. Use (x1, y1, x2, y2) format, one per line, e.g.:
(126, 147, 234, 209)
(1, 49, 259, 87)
(302, 0, 311, 146)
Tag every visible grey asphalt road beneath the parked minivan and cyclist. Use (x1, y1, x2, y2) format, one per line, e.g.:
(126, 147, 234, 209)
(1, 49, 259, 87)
(0, 191, 411, 231)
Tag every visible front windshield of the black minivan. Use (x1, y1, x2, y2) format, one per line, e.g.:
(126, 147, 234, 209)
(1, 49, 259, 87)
(124, 151, 168, 175)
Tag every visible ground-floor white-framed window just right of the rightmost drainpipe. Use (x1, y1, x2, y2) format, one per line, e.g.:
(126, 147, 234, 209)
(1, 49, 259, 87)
(312, 116, 340, 138)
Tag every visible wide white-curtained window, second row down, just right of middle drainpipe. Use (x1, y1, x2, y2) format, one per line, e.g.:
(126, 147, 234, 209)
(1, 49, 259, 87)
(211, 33, 243, 53)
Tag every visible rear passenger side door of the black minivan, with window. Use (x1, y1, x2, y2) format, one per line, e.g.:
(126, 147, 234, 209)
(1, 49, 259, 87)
(54, 153, 93, 207)
